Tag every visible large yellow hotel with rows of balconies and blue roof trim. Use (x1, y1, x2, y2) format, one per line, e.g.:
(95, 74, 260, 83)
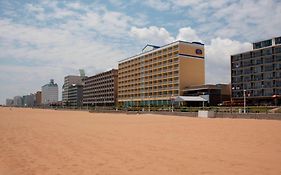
(118, 41, 205, 106)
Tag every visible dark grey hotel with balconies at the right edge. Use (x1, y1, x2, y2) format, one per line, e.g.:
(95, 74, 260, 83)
(231, 37, 281, 104)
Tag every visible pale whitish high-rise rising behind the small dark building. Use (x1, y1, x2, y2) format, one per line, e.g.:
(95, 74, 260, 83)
(62, 75, 83, 106)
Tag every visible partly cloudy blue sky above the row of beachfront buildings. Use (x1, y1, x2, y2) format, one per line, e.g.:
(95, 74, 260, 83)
(0, 0, 281, 104)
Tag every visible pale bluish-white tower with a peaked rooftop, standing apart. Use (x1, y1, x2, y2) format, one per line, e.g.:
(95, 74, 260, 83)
(42, 79, 58, 105)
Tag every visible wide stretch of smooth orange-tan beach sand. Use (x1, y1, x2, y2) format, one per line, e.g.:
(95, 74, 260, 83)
(0, 108, 281, 175)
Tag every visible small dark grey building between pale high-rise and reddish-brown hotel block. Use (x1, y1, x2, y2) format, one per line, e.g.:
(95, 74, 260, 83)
(67, 84, 83, 107)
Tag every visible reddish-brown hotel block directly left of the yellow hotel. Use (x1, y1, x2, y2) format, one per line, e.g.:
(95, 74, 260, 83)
(83, 69, 118, 106)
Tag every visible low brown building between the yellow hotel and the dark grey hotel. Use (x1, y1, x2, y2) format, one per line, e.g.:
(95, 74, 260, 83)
(183, 84, 231, 106)
